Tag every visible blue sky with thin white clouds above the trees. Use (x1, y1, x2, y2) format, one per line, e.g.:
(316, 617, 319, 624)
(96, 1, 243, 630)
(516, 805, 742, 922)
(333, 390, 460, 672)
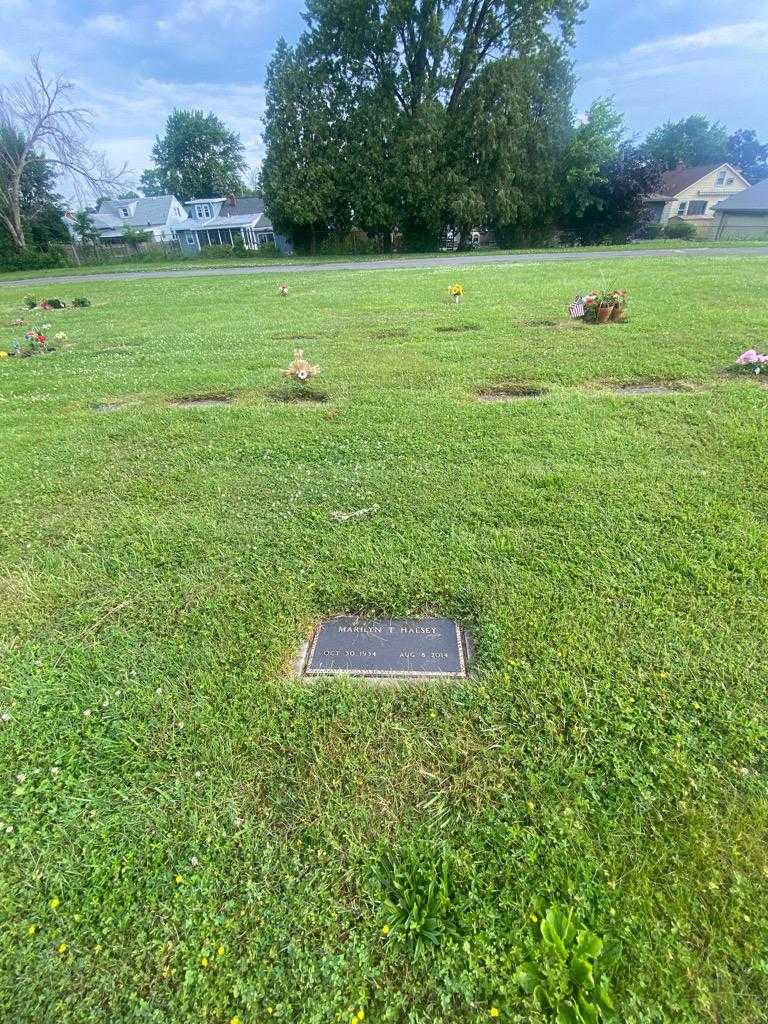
(0, 0, 768, 193)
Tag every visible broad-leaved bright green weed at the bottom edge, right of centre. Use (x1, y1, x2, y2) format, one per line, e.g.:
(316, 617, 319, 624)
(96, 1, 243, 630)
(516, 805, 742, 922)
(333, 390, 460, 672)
(514, 905, 613, 1024)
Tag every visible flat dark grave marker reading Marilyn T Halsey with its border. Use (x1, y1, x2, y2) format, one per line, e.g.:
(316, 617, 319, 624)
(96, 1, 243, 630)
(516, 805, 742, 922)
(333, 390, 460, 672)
(294, 615, 473, 683)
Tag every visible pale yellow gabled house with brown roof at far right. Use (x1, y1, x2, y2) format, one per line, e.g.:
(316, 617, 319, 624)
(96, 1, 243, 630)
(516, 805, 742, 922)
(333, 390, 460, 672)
(645, 164, 750, 236)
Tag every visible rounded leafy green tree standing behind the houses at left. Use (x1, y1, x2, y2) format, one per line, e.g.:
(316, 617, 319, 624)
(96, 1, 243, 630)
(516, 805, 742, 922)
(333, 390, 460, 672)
(140, 110, 247, 202)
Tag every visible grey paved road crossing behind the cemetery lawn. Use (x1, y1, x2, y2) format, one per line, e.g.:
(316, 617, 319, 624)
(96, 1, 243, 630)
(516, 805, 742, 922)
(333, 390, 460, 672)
(0, 246, 768, 288)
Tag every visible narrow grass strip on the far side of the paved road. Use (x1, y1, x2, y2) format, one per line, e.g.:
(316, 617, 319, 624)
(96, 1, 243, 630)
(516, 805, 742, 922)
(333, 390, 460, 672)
(0, 239, 768, 281)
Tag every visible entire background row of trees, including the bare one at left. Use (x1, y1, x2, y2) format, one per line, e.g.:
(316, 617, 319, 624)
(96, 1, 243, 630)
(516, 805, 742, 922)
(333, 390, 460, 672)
(0, 26, 768, 257)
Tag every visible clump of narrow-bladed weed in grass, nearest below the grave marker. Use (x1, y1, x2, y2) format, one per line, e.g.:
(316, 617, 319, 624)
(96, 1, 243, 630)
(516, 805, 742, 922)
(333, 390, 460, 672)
(374, 844, 456, 956)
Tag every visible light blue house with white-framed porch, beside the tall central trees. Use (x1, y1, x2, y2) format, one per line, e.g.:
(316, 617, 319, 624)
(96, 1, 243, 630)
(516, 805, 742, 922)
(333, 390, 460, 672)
(176, 197, 290, 255)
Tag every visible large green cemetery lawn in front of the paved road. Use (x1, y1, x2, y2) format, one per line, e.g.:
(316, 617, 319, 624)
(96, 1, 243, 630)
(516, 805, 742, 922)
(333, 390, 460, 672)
(0, 256, 768, 1024)
